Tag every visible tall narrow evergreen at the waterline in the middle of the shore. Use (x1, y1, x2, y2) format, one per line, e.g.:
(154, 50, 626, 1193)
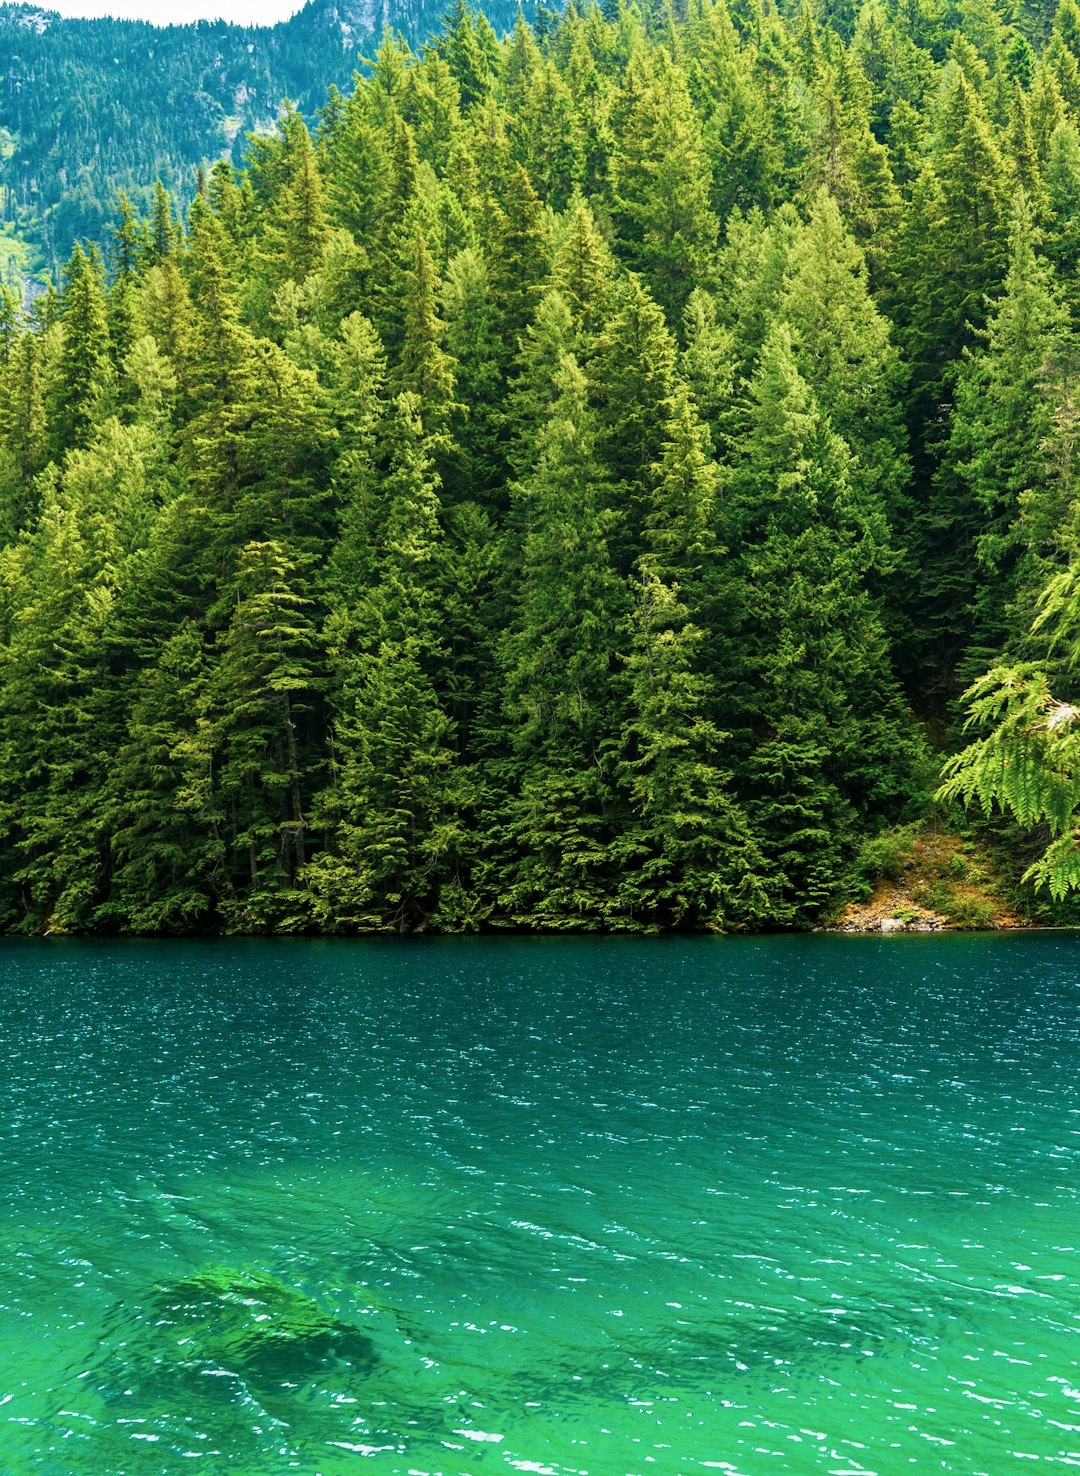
(493, 354, 624, 927)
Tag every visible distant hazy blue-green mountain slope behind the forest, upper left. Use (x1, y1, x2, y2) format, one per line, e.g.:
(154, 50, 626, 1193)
(0, 0, 536, 279)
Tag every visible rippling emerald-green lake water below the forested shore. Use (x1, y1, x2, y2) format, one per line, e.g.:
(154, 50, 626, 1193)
(0, 934, 1080, 1476)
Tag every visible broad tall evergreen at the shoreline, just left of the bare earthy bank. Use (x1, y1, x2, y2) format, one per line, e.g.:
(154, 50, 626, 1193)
(721, 323, 910, 918)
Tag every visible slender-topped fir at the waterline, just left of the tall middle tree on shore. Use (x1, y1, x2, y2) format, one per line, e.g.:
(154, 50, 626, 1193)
(307, 393, 462, 931)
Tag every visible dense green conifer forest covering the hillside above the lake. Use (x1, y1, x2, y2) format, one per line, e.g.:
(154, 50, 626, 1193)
(0, 0, 1080, 933)
